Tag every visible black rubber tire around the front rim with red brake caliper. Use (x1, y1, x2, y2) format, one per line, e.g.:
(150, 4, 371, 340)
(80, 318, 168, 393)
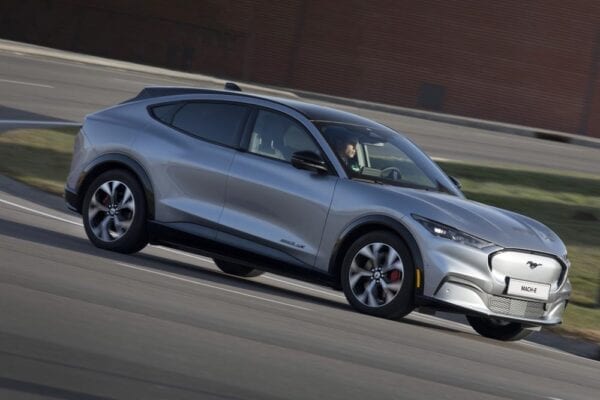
(340, 231, 415, 319)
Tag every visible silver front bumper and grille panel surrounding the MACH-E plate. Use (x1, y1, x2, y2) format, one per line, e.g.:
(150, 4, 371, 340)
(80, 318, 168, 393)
(424, 242, 571, 326)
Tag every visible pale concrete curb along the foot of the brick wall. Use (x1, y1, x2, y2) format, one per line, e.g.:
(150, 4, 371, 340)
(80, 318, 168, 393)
(0, 39, 600, 149)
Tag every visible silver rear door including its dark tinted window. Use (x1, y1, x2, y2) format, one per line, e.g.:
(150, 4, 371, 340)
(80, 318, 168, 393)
(141, 101, 250, 237)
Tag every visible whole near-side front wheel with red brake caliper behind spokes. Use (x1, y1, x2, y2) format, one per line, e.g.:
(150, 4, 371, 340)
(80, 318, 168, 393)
(341, 231, 415, 319)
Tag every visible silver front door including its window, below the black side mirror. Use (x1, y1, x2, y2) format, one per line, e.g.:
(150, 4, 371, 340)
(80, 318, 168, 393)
(217, 109, 338, 266)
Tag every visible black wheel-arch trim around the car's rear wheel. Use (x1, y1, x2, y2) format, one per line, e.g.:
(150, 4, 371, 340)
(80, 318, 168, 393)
(76, 153, 154, 219)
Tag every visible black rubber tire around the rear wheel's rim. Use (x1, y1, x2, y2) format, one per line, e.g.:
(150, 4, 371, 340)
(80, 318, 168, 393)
(82, 169, 148, 254)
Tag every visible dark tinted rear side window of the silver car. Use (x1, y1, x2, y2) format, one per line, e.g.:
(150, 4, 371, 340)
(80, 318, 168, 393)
(152, 102, 249, 147)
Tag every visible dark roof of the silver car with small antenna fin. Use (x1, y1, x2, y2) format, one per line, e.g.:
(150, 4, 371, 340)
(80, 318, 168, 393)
(127, 86, 374, 126)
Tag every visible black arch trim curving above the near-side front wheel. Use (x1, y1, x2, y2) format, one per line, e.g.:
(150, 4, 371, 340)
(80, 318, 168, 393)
(329, 215, 424, 295)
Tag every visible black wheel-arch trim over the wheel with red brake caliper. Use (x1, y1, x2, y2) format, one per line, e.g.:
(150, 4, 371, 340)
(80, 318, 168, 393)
(329, 215, 424, 294)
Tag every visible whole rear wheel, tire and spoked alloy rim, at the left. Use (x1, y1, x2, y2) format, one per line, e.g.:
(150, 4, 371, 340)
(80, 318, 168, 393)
(82, 170, 148, 253)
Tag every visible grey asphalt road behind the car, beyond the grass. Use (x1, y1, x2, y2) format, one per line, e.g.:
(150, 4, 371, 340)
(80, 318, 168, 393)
(0, 48, 600, 174)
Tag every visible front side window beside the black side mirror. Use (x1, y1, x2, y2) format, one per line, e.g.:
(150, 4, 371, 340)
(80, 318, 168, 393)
(248, 110, 321, 162)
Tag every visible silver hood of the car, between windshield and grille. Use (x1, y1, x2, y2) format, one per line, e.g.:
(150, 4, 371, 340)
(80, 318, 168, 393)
(392, 188, 566, 257)
